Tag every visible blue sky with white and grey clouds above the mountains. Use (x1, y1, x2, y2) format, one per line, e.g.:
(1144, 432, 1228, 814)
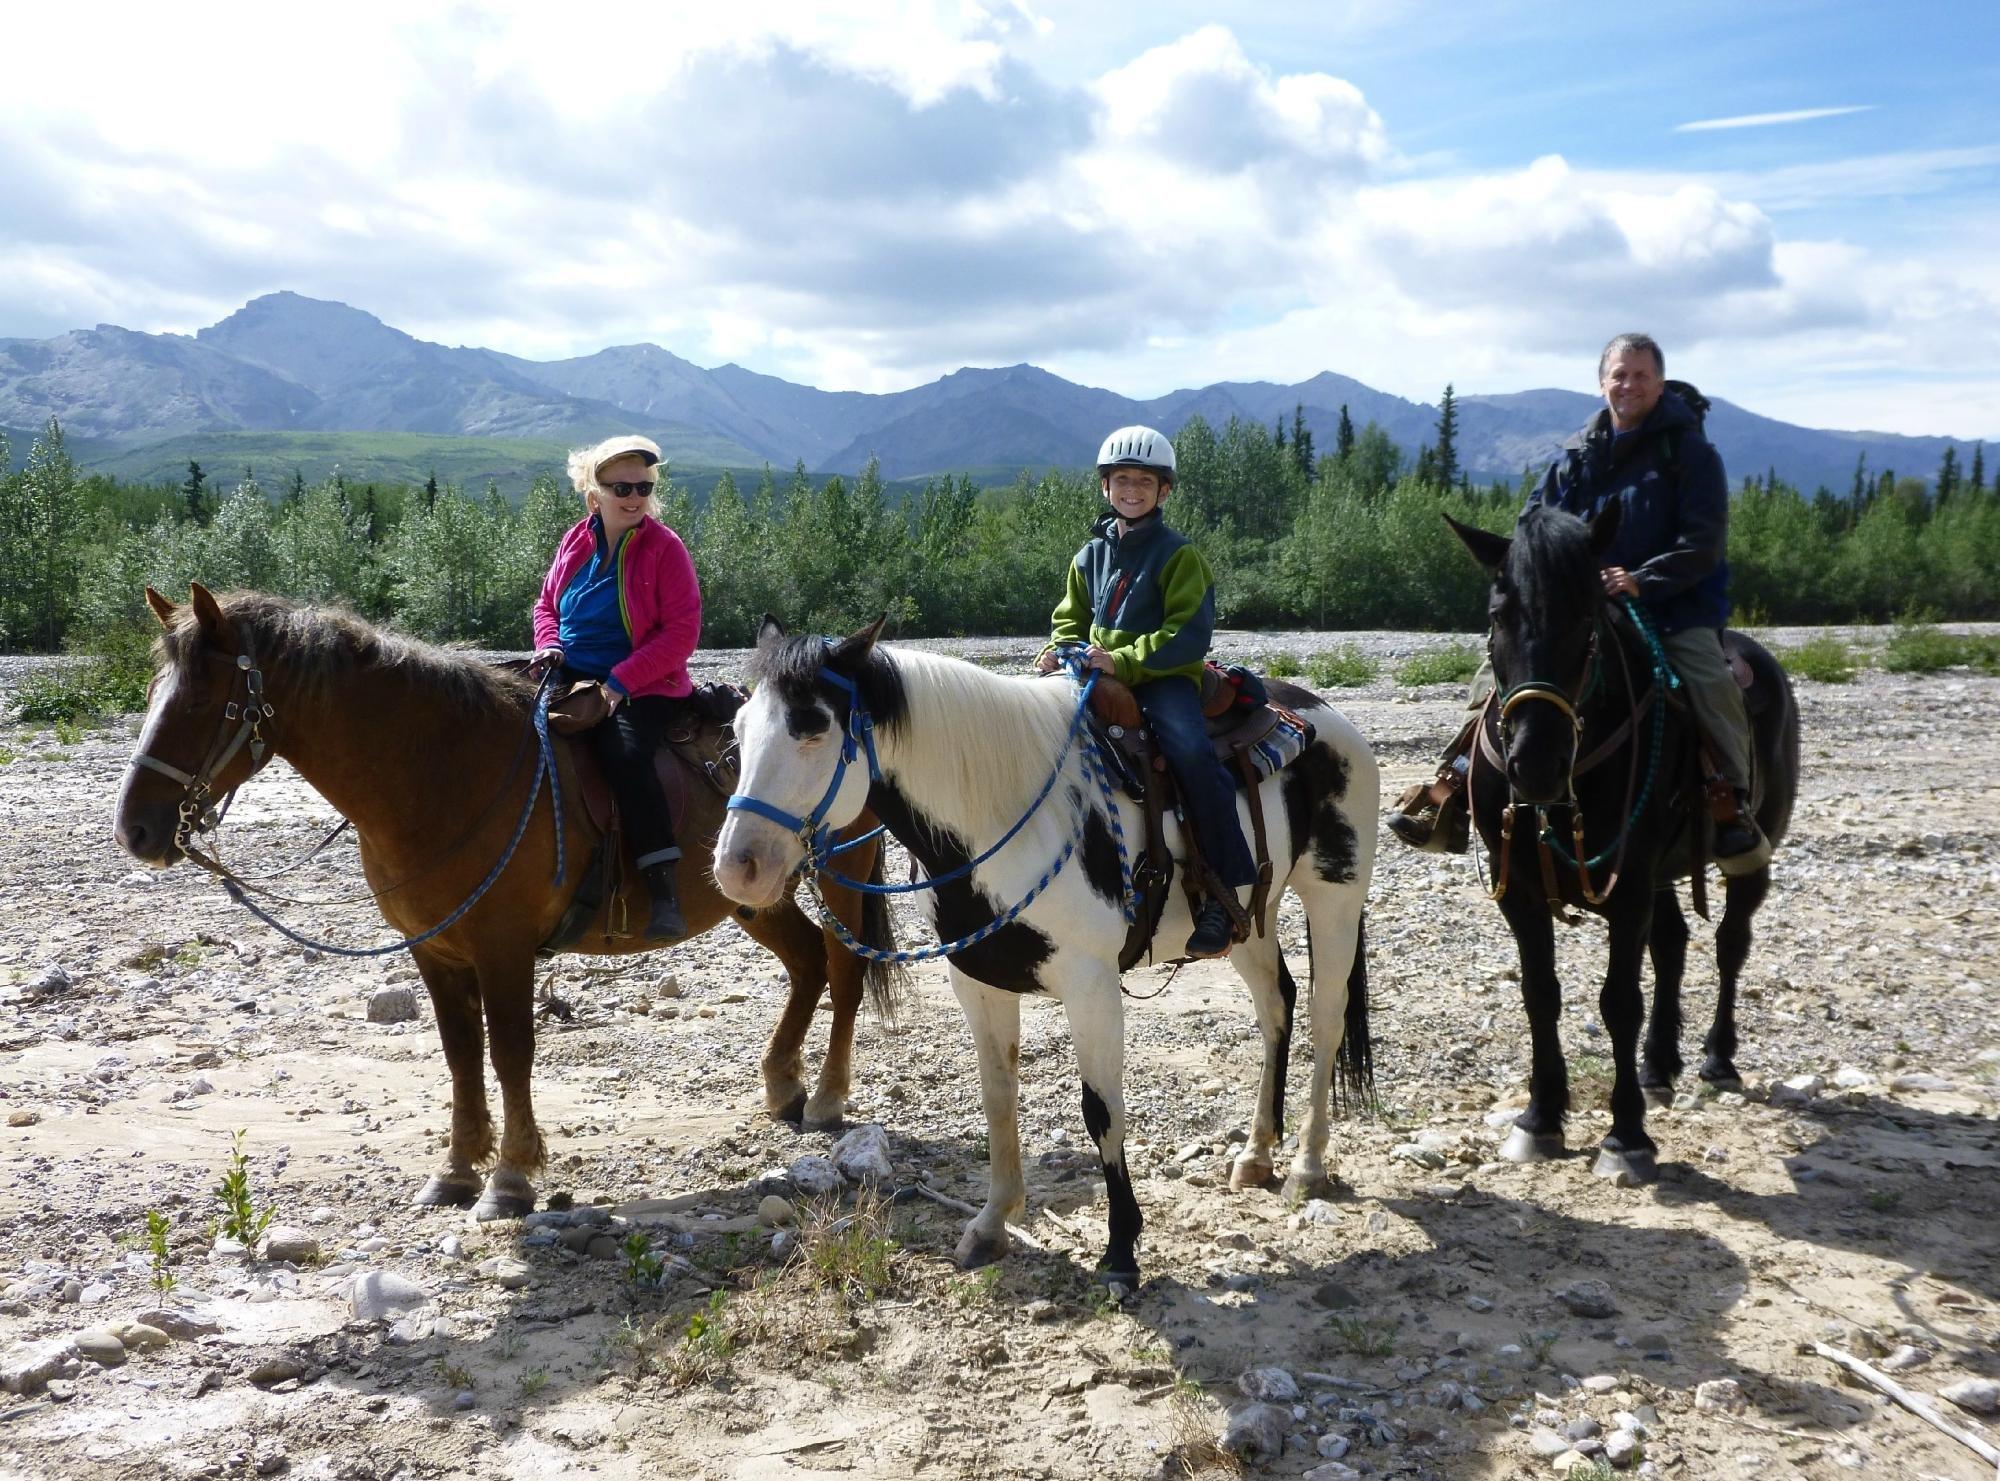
(0, 0, 2000, 436)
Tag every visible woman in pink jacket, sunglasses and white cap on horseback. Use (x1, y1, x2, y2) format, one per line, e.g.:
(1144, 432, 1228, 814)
(534, 436, 702, 941)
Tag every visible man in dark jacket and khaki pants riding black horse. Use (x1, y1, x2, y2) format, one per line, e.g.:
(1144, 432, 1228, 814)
(1388, 334, 1770, 875)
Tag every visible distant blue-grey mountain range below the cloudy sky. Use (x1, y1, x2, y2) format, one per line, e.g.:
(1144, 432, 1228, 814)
(0, 292, 1972, 492)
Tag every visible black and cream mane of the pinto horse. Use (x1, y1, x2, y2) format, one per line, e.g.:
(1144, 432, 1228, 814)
(750, 636, 1072, 839)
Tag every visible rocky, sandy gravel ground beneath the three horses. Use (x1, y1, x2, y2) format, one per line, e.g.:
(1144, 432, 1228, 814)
(0, 634, 2000, 1481)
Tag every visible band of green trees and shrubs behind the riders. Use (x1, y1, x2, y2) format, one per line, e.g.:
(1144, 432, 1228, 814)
(0, 408, 2000, 650)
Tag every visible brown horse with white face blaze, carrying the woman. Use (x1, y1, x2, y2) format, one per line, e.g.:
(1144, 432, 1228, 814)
(116, 584, 892, 1219)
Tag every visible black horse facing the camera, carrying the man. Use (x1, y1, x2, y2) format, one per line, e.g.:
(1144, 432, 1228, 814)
(1446, 504, 1798, 1185)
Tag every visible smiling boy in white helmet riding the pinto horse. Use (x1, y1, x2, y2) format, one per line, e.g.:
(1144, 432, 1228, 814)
(1036, 426, 1256, 957)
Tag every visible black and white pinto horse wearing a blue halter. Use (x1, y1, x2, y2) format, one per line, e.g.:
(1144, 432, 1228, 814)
(714, 618, 1380, 1289)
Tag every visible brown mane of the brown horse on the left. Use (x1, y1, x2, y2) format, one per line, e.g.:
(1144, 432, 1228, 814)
(160, 590, 534, 720)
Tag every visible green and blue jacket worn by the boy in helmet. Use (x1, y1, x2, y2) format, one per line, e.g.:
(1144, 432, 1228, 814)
(1050, 512, 1216, 684)
